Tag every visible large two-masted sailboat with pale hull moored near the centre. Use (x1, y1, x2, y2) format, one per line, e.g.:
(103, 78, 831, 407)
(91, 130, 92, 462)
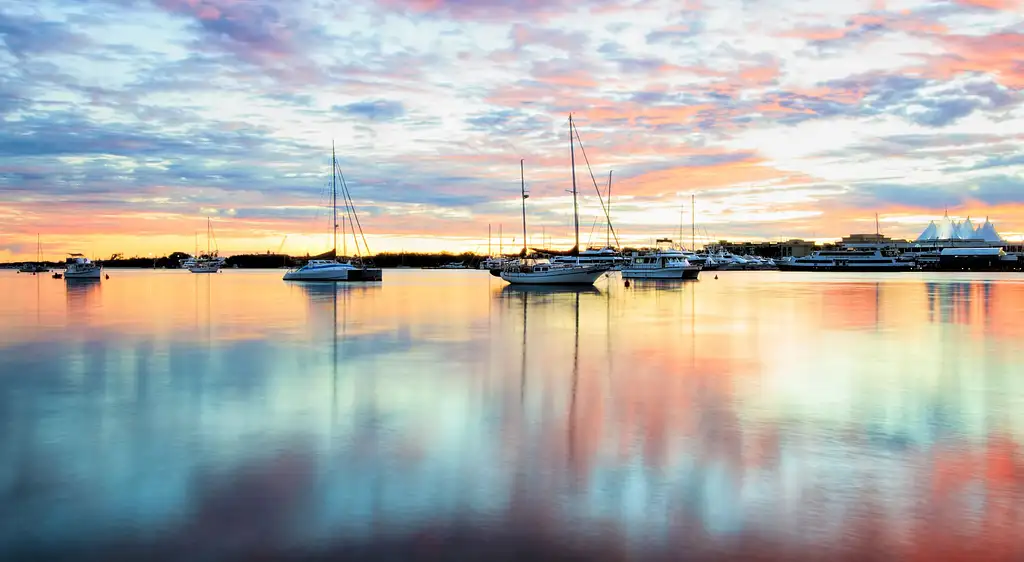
(501, 115, 611, 285)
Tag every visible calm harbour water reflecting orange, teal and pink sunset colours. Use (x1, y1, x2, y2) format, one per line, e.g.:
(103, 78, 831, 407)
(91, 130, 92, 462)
(0, 270, 1024, 560)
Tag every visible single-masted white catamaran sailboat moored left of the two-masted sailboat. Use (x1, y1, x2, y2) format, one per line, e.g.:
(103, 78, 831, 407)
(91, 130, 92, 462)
(285, 144, 383, 282)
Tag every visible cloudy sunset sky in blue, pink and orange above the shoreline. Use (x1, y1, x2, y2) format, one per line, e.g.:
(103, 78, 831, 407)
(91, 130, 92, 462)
(0, 0, 1024, 261)
